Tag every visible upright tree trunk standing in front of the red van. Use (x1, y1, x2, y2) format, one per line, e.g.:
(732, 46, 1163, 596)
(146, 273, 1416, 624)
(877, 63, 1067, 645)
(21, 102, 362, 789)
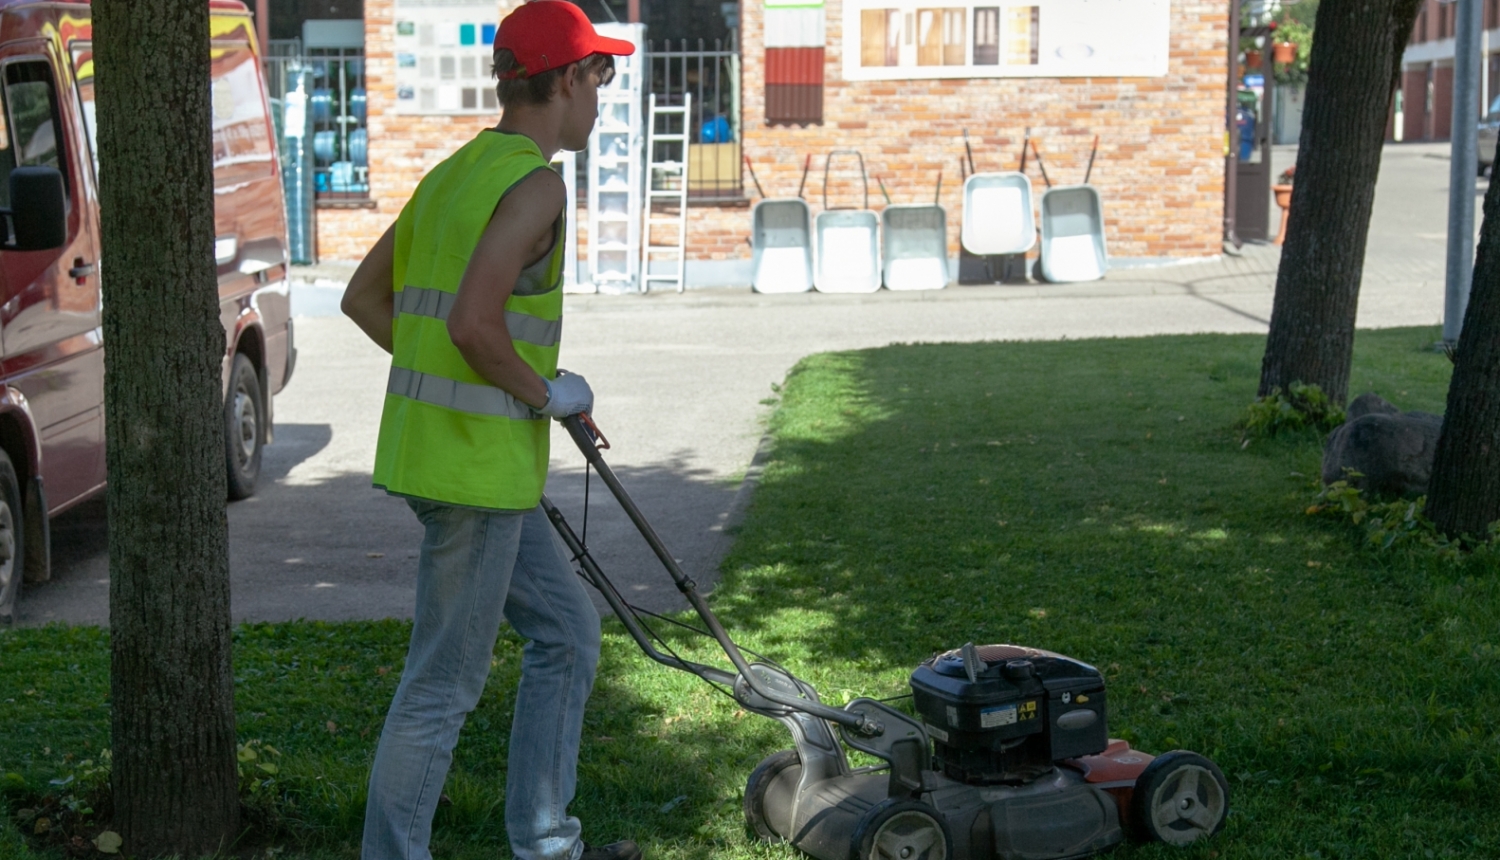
(93, 0, 239, 857)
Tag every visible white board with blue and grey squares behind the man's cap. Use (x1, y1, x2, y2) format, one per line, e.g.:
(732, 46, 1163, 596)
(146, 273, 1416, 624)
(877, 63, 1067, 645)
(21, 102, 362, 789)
(395, 0, 500, 116)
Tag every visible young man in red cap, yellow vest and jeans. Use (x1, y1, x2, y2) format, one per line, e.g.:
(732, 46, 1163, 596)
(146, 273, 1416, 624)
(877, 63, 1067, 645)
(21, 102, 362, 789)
(344, 0, 641, 860)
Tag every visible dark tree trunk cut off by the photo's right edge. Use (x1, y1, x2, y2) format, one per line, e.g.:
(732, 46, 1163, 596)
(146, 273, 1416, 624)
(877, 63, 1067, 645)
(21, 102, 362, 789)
(1427, 147, 1500, 537)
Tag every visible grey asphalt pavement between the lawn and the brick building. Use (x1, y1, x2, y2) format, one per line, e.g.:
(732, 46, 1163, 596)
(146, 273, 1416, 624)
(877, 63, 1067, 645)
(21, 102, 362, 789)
(18, 138, 1485, 626)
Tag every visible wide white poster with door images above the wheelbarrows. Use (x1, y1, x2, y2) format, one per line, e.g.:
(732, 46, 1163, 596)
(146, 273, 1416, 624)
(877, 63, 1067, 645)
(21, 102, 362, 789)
(843, 0, 1172, 81)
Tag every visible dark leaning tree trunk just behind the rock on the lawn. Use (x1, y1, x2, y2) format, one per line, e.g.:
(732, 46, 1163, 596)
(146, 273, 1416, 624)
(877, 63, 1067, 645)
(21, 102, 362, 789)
(1260, 0, 1419, 404)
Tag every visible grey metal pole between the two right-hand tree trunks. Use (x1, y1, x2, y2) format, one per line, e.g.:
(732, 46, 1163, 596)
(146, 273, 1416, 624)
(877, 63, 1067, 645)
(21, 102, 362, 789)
(1443, 0, 1484, 344)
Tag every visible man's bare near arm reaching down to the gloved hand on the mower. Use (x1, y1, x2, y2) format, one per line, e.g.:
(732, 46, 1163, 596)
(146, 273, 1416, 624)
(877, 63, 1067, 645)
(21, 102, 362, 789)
(449, 170, 566, 408)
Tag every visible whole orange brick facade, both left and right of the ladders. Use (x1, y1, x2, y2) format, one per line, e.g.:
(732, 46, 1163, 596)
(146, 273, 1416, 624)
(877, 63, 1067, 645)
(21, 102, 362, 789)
(307, 0, 1229, 274)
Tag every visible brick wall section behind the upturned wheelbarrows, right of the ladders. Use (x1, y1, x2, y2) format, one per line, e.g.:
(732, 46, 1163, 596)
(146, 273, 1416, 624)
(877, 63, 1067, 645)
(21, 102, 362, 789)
(720, 0, 1229, 257)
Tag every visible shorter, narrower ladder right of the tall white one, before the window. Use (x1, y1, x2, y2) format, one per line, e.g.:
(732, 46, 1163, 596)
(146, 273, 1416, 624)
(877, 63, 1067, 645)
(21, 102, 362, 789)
(641, 93, 693, 293)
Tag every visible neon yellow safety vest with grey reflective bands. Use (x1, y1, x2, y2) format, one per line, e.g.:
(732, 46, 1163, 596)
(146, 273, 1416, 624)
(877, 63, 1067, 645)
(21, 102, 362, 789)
(374, 131, 566, 510)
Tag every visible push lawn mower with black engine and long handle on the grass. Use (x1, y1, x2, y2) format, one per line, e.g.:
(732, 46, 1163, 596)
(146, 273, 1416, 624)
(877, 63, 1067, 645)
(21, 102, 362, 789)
(542, 414, 1229, 860)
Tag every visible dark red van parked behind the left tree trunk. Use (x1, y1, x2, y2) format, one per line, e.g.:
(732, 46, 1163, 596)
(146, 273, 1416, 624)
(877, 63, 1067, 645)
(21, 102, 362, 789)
(0, 0, 296, 617)
